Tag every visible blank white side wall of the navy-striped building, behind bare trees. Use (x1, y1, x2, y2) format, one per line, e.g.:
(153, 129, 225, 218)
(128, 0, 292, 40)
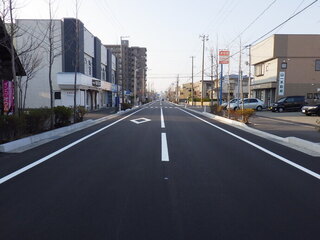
(16, 20, 62, 108)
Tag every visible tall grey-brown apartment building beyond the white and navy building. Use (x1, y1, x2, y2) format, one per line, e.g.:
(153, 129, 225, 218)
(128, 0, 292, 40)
(105, 40, 147, 102)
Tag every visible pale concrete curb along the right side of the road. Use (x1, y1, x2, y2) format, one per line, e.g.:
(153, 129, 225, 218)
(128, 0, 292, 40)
(187, 108, 320, 157)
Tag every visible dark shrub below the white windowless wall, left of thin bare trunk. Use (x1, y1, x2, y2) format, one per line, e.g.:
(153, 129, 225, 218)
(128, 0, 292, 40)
(25, 108, 52, 133)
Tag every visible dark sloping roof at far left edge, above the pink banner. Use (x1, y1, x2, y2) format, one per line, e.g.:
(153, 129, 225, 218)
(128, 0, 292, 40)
(0, 19, 26, 80)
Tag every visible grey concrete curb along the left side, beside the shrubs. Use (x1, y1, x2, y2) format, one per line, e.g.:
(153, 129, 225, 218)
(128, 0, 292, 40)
(0, 105, 146, 153)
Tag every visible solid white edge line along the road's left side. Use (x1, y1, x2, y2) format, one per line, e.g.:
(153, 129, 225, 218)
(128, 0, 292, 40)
(0, 109, 143, 184)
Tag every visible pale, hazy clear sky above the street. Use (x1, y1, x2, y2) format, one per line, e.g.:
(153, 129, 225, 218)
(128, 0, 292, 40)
(11, 0, 320, 91)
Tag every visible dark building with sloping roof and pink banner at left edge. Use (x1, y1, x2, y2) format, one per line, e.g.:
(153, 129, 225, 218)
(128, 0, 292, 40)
(0, 19, 26, 115)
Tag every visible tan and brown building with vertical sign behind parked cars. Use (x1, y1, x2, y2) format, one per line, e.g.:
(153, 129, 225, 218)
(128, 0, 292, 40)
(250, 34, 320, 106)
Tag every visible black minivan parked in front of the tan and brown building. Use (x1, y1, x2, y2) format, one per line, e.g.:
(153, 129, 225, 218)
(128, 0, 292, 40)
(271, 96, 306, 112)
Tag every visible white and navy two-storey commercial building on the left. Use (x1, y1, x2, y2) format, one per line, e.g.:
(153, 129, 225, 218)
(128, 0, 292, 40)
(16, 18, 120, 110)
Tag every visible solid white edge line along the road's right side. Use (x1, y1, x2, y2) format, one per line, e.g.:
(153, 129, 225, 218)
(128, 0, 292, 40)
(179, 108, 320, 180)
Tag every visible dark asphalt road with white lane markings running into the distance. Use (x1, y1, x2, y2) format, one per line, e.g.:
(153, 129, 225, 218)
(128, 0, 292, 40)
(0, 101, 320, 240)
